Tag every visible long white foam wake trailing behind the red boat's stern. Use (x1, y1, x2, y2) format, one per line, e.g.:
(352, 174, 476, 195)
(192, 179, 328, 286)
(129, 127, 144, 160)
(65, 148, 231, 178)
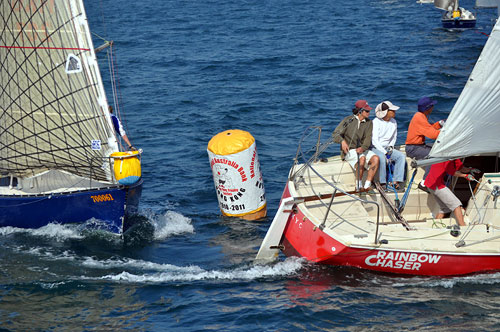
(95, 257, 303, 283)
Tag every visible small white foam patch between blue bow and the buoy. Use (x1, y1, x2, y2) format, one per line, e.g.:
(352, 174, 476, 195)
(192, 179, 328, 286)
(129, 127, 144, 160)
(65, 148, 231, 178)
(150, 211, 194, 240)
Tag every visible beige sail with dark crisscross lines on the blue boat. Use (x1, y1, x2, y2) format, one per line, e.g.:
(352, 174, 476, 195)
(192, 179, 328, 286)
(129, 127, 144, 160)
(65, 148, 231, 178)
(0, 0, 118, 180)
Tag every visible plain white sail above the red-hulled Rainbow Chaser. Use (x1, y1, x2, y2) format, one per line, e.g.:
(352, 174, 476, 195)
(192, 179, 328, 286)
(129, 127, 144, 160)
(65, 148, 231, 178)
(426, 20, 500, 164)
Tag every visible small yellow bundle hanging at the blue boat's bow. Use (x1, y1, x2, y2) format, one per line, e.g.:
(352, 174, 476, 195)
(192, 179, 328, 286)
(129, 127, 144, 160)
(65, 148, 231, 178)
(110, 151, 141, 186)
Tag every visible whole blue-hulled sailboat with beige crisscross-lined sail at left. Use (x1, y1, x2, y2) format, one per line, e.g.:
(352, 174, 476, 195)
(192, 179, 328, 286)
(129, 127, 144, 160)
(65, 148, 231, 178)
(0, 0, 142, 234)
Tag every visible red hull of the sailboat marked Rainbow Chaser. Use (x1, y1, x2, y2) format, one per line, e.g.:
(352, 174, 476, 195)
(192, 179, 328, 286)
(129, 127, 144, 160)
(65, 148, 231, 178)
(282, 187, 500, 276)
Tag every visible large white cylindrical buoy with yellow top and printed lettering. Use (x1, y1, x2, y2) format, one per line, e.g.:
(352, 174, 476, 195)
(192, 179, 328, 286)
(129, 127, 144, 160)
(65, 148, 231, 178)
(207, 129, 267, 220)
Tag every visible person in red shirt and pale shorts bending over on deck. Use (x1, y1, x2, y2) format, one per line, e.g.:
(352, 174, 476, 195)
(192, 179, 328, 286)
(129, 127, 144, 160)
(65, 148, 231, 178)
(425, 159, 474, 226)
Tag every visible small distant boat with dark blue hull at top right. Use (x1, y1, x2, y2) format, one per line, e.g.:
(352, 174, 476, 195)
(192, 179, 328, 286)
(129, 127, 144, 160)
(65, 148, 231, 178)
(434, 0, 476, 29)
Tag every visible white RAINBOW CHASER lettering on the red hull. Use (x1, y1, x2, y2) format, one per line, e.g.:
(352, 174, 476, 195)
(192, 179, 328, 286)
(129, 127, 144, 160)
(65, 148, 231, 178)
(365, 251, 441, 270)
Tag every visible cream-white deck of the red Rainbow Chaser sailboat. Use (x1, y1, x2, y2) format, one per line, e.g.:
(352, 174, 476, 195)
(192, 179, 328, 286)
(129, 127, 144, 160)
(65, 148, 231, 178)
(288, 156, 500, 254)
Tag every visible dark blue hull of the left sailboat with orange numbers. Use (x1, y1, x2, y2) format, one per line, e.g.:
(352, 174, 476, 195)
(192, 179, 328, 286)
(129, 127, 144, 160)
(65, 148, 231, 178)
(0, 179, 142, 234)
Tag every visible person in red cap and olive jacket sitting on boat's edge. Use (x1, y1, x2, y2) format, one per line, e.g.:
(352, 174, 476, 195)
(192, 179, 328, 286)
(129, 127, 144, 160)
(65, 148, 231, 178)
(332, 100, 379, 191)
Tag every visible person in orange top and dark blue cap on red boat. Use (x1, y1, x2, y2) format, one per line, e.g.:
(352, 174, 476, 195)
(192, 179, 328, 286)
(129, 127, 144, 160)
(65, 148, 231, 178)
(405, 97, 444, 191)
